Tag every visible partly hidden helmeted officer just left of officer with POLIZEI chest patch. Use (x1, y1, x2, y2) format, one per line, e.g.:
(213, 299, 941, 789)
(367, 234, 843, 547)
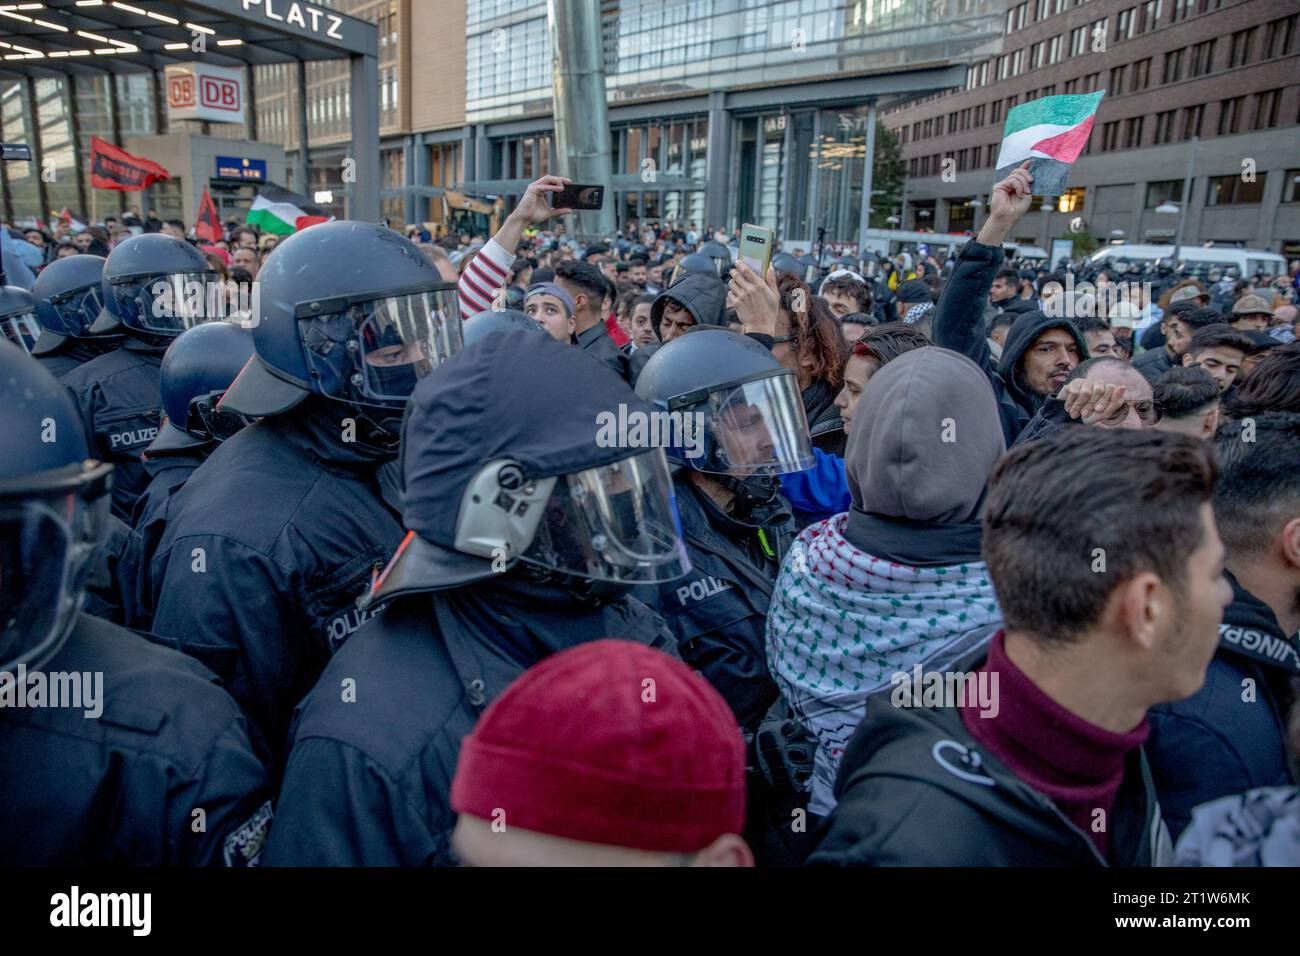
(31, 255, 122, 378)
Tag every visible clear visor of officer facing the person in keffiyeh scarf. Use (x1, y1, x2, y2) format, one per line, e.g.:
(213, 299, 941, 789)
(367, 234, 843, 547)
(686, 375, 813, 477)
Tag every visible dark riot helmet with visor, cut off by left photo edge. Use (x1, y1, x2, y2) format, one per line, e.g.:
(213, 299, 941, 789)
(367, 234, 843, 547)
(0, 342, 113, 674)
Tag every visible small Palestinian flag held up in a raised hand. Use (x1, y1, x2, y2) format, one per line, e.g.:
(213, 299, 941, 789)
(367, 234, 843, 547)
(993, 90, 1106, 196)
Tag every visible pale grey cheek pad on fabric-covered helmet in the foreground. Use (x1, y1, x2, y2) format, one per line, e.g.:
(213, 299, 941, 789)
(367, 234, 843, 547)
(455, 459, 559, 562)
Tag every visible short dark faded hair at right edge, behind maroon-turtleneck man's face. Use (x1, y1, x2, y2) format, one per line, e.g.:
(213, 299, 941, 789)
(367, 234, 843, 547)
(1214, 412, 1300, 558)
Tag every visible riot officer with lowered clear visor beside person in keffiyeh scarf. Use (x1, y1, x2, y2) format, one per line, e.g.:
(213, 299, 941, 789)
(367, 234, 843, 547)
(637, 326, 813, 731)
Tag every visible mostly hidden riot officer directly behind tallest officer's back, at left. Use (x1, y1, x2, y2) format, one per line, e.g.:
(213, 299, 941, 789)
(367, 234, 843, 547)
(114, 323, 254, 631)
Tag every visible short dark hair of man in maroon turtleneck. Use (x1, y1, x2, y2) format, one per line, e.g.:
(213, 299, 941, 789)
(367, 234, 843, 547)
(984, 428, 1217, 644)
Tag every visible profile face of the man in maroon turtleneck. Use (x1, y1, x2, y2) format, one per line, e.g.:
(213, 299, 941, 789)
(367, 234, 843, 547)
(1149, 503, 1232, 702)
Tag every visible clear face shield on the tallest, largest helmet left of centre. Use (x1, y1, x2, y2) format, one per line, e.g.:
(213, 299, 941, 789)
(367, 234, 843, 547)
(299, 284, 462, 408)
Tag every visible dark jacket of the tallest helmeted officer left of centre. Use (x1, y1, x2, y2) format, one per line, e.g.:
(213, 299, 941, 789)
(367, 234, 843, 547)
(148, 398, 403, 757)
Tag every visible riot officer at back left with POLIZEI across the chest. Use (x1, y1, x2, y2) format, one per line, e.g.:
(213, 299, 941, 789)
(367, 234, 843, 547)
(62, 233, 216, 522)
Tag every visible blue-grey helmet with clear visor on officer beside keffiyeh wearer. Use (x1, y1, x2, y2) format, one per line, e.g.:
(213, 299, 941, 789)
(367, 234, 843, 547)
(637, 326, 813, 480)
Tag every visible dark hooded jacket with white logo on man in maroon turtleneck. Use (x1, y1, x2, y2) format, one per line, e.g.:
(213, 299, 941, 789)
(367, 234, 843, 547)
(809, 648, 1173, 866)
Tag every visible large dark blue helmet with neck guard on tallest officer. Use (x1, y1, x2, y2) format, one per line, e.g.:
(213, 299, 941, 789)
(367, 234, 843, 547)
(221, 220, 462, 445)
